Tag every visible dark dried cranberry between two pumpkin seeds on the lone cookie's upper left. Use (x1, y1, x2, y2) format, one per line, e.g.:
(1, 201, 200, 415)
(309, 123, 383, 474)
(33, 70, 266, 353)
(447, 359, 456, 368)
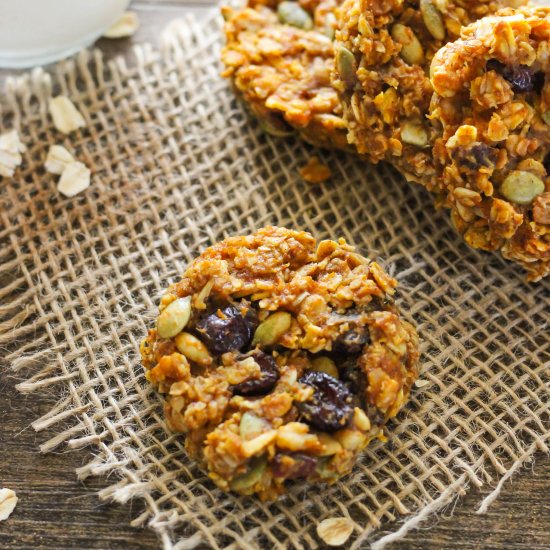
(197, 306, 258, 353)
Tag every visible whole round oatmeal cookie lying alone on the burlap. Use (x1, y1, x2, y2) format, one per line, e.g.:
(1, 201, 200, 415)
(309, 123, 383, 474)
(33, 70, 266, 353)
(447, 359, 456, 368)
(141, 227, 418, 499)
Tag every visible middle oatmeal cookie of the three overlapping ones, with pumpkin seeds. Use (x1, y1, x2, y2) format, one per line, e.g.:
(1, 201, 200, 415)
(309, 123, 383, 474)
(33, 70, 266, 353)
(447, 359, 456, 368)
(333, 0, 526, 185)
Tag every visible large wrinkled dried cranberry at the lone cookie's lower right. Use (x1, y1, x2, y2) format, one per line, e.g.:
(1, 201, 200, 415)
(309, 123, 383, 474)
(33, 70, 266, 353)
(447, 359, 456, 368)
(298, 371, 353, 432)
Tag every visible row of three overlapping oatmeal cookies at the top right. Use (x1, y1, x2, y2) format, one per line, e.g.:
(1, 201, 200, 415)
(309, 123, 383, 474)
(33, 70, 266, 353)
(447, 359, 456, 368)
(222, 0, 550, 281)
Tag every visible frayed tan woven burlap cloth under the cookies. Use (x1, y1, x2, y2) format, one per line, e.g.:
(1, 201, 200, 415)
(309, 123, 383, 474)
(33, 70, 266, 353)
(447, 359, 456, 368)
(0, 12, 550, 548)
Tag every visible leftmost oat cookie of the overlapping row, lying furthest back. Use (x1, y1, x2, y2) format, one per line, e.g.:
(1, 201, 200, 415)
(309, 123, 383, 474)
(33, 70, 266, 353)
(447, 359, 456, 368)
(221, 0, 351, 149)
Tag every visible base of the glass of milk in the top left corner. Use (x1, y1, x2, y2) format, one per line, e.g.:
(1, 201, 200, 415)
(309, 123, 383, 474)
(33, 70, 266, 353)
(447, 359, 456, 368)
(0, 0, 130, 67)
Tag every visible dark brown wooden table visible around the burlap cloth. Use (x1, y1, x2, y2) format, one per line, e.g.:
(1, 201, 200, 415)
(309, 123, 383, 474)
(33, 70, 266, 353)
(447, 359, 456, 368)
(0, 0, 550, 550)
